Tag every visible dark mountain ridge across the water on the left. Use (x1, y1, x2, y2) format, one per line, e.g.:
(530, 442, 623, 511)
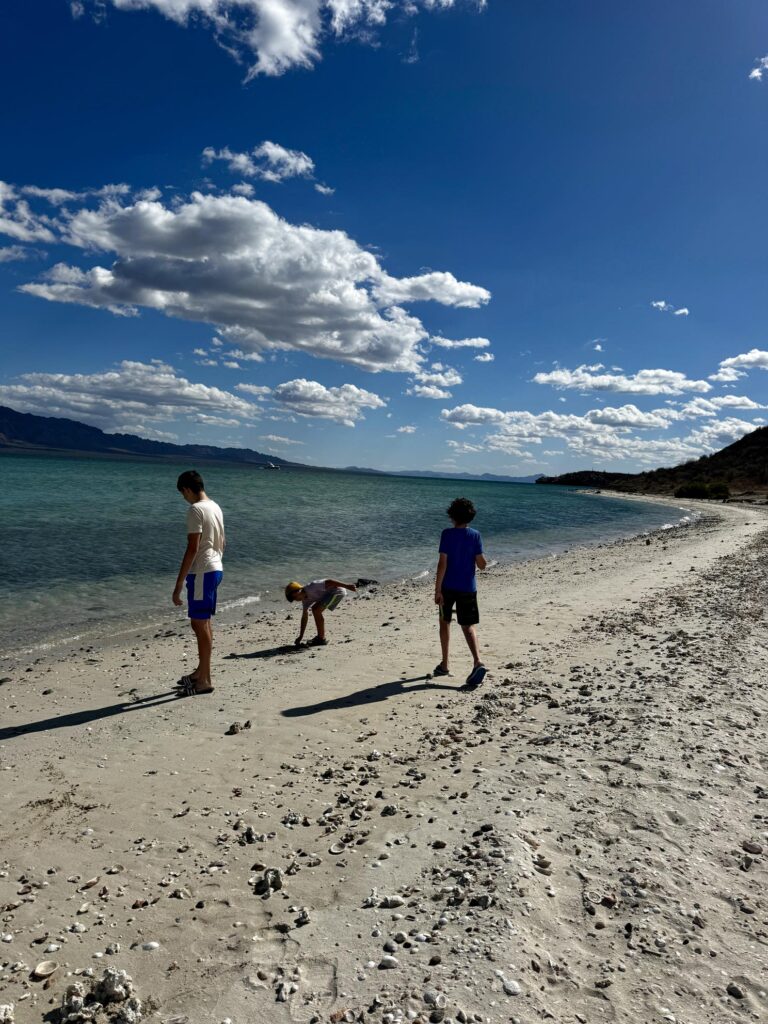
(0, 406, 296, 468)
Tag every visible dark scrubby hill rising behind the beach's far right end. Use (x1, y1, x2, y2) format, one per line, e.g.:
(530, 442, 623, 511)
(537, 427, 768, 495)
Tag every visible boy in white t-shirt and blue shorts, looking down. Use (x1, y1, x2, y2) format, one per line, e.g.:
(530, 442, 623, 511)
(173, 469, 225, 697)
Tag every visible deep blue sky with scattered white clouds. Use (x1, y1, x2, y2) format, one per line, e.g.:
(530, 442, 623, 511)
(0, 0, 768, 473)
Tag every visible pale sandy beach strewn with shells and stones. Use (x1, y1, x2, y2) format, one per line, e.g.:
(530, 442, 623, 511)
(0, 499, 768, 1024)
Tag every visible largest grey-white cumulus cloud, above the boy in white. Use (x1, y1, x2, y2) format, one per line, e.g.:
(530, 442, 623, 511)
(7, 186, 489, 383)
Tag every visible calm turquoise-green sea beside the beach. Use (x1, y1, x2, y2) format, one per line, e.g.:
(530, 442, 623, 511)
(0, 456, 689, 651)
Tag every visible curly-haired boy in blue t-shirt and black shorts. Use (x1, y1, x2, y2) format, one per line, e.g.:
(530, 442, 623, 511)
(433, 498, 487, 687)
